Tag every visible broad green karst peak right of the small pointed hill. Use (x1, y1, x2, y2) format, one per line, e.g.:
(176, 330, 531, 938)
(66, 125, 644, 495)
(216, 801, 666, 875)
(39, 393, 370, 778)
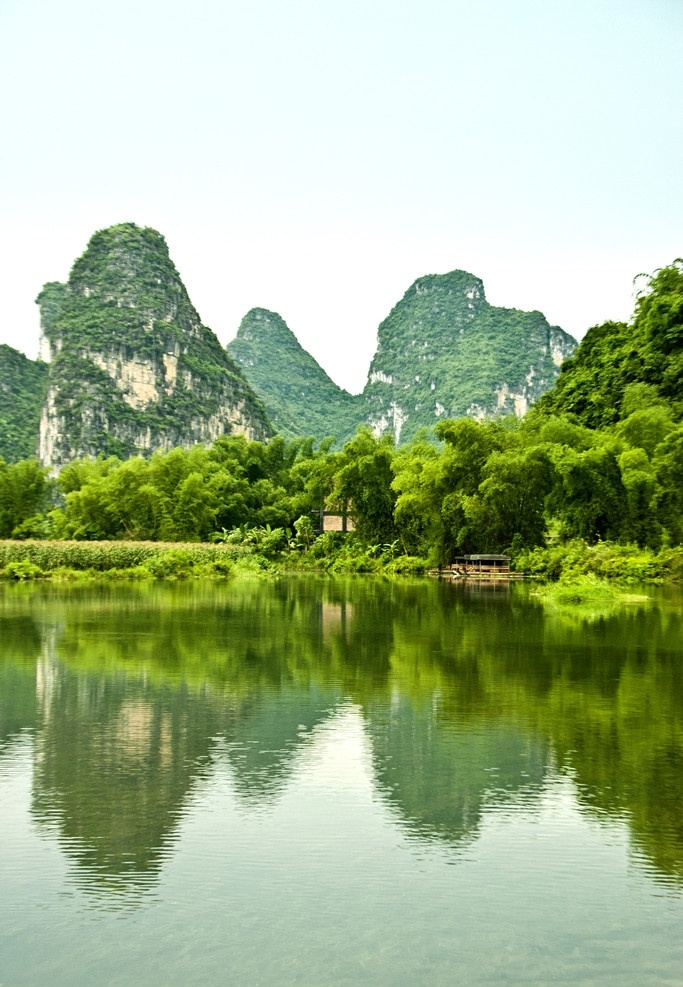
(363, 271, 577, 442)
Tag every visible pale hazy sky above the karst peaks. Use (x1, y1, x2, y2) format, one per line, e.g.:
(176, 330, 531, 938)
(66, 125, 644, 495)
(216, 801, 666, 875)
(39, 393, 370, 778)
(0, 0, 683, 391)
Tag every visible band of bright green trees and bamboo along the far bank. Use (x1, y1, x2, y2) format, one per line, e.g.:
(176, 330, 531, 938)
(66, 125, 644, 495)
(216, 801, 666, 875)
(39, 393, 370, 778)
(0, 262, 683, 592)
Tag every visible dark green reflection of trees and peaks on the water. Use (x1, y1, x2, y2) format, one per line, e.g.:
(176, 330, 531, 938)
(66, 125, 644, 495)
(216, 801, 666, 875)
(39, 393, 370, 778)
(0, 579, 683, 893)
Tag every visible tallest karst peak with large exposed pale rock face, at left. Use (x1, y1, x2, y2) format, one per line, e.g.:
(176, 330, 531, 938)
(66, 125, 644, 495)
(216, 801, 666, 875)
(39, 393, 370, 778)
(37, 223, 272, 467)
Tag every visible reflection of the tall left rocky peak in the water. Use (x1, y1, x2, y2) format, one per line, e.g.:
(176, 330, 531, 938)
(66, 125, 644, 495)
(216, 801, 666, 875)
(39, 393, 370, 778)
(32, 658, 219, 891)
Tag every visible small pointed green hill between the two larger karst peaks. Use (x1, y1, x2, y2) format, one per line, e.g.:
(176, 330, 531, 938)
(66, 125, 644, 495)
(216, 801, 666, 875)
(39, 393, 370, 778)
(228, 308, 363, 444)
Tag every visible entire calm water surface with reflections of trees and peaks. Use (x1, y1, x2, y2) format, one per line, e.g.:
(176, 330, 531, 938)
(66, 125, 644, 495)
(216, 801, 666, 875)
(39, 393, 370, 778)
(0, 578, 683, 987)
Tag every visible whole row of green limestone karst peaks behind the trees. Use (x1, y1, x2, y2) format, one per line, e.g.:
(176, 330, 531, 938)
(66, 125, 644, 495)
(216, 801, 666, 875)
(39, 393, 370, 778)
(0, 223, 577, 469)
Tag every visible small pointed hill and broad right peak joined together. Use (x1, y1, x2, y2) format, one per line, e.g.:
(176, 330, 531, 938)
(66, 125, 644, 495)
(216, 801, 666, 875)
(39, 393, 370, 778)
(228, 271, 576, 443)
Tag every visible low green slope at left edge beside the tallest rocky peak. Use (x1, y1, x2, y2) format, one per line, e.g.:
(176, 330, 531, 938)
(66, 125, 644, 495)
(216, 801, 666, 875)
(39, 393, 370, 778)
(0, 343, 47, 463)
